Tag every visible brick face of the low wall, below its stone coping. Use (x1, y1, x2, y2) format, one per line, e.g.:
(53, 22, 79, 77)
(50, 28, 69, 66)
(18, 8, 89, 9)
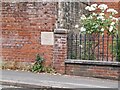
(65, 64, 119, 80)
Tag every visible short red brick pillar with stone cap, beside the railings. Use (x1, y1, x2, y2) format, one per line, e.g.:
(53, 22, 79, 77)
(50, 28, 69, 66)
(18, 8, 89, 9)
(53, 29, 67, 73)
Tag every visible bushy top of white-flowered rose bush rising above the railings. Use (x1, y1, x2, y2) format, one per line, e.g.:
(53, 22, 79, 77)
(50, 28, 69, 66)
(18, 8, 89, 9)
(80, 4, 118, 35)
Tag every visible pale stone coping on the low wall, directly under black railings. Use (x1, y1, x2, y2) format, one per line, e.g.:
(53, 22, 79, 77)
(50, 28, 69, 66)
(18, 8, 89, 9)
(65, 59, 120, 67)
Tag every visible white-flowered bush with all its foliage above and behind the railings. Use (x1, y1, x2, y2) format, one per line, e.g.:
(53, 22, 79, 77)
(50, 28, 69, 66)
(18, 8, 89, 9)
(80, 4, 120, 60)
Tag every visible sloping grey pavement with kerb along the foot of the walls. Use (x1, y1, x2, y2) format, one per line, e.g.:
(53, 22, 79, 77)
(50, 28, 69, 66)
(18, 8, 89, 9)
(0, 70, 119, 90)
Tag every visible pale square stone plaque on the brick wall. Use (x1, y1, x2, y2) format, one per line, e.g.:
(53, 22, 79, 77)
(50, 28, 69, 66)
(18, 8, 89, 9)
(41, 32, 54, 45)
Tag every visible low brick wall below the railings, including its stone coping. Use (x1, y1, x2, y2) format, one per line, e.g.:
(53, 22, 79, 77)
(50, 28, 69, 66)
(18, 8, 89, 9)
(65, 61, 120, 80)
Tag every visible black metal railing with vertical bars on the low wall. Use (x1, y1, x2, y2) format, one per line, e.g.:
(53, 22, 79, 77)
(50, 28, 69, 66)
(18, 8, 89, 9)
(68, 33, 120, 61)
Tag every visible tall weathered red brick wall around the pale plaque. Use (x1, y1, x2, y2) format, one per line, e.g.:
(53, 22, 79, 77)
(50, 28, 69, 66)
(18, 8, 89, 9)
(2, 2, 56, 65)
